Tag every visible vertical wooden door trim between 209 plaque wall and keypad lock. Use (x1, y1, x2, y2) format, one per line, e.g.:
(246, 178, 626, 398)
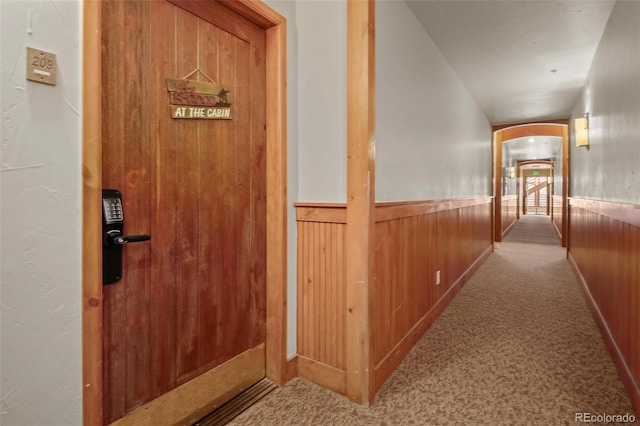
(82, 0, 103, 425)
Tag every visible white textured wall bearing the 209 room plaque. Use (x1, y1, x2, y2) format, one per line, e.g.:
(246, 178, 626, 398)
(0, 0, 82, 426)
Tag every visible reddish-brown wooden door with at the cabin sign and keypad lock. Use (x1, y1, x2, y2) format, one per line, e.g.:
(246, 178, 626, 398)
(102, 0, 266, 423)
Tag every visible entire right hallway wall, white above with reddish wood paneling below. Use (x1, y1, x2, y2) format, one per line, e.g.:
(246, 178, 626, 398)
(569, 1, 640, 412)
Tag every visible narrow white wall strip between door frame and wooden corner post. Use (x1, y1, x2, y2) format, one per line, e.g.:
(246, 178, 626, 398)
(298, 0, 347, 202)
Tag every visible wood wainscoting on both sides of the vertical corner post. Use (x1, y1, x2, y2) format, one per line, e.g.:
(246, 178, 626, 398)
(296, 197, 493, 402)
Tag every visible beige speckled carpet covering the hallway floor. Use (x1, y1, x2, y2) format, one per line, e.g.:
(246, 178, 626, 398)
(231, 216, 634, 425)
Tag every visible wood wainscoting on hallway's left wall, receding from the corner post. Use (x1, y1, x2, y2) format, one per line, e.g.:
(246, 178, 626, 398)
(369, 197, 492, 393)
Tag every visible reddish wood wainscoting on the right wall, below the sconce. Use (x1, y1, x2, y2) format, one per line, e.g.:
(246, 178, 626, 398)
(569, 198, 640, 412)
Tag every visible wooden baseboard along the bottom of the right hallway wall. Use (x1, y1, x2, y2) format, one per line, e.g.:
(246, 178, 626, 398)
(568, 252, 640, 413)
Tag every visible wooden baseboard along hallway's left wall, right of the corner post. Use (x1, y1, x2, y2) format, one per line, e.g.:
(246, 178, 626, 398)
(371, 244, 493, 395)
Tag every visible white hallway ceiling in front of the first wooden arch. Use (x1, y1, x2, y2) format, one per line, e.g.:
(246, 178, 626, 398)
(407, 0, 615, 124)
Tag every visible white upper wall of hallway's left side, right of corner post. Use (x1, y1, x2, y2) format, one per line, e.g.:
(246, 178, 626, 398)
(376, 1, 492, 201)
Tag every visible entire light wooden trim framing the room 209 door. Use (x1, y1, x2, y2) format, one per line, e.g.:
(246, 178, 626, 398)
(82, 0, 287, 425)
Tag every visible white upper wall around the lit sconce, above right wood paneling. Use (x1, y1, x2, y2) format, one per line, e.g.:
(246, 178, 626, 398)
(569, 1, 640, 204)
